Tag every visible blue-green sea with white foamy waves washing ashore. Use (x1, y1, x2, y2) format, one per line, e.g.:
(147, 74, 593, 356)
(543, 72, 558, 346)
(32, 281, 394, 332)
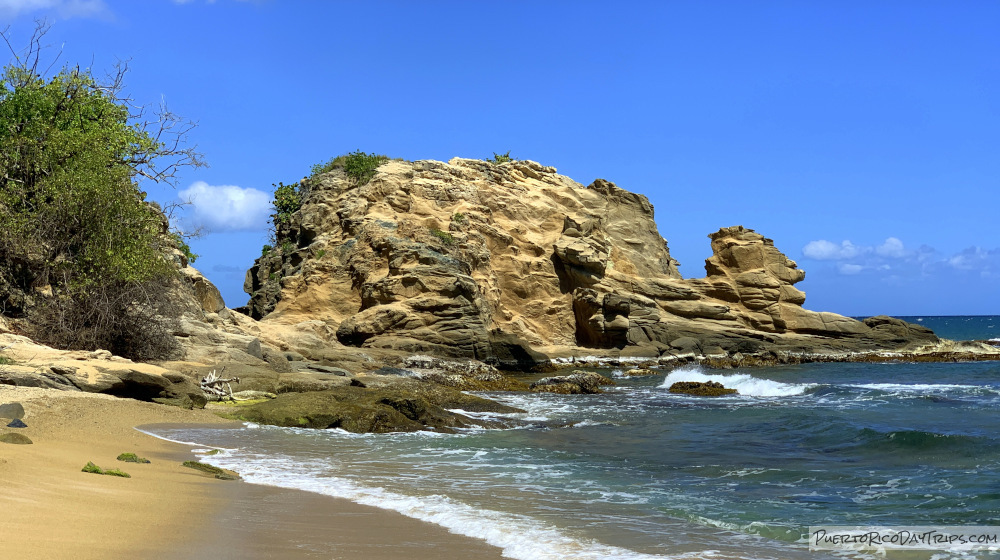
(148, 317, 1000, 560)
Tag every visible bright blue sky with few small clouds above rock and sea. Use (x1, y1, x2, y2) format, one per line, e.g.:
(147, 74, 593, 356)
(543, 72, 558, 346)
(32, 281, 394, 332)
(0, 0, 1000, 315)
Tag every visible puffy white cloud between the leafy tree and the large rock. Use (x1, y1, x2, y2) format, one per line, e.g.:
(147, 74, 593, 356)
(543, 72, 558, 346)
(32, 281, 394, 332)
(177, 181, 271, 231)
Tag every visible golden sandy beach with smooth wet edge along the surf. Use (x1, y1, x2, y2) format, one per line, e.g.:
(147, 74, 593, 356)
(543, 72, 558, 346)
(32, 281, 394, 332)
(0, 385, 501, 560)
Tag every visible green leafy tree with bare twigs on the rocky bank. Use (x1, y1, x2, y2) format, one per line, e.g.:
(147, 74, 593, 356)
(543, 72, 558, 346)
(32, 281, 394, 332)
(0, 25, 201, 358)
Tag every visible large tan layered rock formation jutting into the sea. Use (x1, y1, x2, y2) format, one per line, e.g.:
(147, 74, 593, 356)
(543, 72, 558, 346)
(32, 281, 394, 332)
(245, 158, 937, 365)
